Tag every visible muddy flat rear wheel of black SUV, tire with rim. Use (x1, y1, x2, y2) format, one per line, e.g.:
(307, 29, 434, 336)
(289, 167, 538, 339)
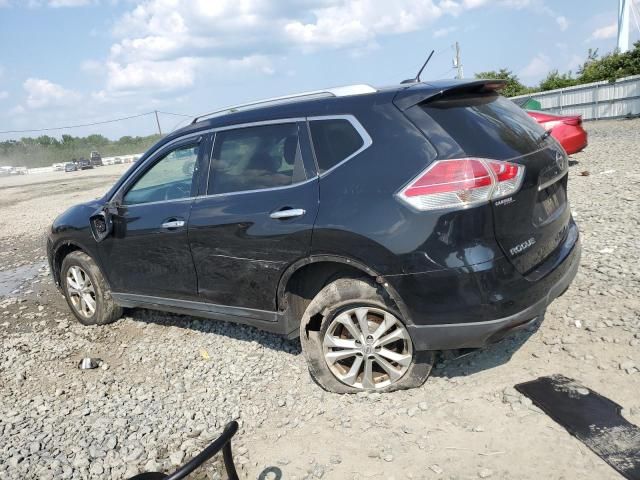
(300, 278, 435, 393)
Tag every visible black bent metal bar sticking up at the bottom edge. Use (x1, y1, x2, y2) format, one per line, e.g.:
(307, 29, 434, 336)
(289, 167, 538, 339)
(129, 420, 238, 480)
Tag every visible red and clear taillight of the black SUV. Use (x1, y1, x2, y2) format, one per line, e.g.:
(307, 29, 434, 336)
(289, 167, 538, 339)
(398, 158, 524, 210)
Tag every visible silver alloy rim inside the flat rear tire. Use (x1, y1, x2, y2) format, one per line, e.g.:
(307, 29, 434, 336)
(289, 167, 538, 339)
(323, 306, 413, 390)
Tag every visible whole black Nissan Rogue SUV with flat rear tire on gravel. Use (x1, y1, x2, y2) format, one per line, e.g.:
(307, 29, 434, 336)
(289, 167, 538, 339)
(48, 81, 580, 392)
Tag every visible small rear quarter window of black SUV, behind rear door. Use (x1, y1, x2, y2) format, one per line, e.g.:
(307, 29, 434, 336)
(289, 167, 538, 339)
(309, 119, 364, 173)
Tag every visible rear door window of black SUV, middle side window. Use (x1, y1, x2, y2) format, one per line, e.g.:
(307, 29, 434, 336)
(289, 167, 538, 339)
(208, 123, 306, 194)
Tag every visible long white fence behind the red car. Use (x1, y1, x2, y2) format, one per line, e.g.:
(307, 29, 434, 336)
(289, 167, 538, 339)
(513, 75, 640, 120)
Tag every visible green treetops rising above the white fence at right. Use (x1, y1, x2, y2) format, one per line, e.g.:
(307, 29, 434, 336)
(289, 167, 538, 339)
(475, 41, 640, 97)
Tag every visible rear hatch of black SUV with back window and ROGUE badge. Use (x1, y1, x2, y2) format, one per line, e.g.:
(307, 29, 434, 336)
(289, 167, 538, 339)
(405, 89, 571, 274)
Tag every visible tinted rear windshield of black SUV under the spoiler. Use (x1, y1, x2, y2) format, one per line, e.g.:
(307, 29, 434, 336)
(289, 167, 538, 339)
(420, 93, 544, 160)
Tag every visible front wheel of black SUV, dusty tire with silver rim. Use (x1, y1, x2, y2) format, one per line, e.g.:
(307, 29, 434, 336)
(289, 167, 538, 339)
(60, 251, 122, 325)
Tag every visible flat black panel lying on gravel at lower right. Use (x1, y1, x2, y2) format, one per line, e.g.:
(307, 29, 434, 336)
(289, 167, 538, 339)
(515, 375, 640, 480)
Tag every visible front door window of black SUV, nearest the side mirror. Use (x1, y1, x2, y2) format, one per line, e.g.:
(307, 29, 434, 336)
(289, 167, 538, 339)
(124, 142, 198, 205)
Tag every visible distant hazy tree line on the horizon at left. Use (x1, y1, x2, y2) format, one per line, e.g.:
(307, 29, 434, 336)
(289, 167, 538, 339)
(0, 134, 161, 168)
